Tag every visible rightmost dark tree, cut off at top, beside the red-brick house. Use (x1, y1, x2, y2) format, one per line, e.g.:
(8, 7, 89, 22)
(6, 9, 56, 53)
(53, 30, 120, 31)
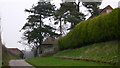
(82, 2, 101, 18)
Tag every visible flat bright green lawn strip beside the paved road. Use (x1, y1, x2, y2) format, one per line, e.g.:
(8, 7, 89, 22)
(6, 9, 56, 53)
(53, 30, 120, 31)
(26, 57, 112, 66)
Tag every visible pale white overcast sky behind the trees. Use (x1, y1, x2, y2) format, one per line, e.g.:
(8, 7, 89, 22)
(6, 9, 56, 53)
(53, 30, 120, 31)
(0, 0, 120, 50)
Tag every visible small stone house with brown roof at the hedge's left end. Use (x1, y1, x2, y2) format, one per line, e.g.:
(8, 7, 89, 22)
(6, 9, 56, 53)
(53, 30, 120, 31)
(37, 37, 57, 56)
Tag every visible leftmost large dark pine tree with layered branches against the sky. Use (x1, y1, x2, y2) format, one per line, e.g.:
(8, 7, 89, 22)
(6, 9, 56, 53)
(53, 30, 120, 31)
(22, 2, 58, 50)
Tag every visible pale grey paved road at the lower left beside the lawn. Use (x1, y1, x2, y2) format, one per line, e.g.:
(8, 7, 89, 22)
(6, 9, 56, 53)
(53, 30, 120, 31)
(9, 60, 35, 68)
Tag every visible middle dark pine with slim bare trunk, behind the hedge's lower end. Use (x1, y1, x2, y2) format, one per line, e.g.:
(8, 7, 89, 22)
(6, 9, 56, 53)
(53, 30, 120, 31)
(54, 2, 85, 34)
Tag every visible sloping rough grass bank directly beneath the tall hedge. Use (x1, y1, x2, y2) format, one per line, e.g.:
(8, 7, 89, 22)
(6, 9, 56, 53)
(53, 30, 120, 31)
(54, 41, 120, 64)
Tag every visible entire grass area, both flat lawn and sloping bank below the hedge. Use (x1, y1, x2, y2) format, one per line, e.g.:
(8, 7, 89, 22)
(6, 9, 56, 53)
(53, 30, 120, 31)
(26, 41, 120, 66)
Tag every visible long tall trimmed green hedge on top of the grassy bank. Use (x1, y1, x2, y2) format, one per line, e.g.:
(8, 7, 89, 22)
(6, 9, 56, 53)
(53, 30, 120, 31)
(58, 8, 120, 49)
